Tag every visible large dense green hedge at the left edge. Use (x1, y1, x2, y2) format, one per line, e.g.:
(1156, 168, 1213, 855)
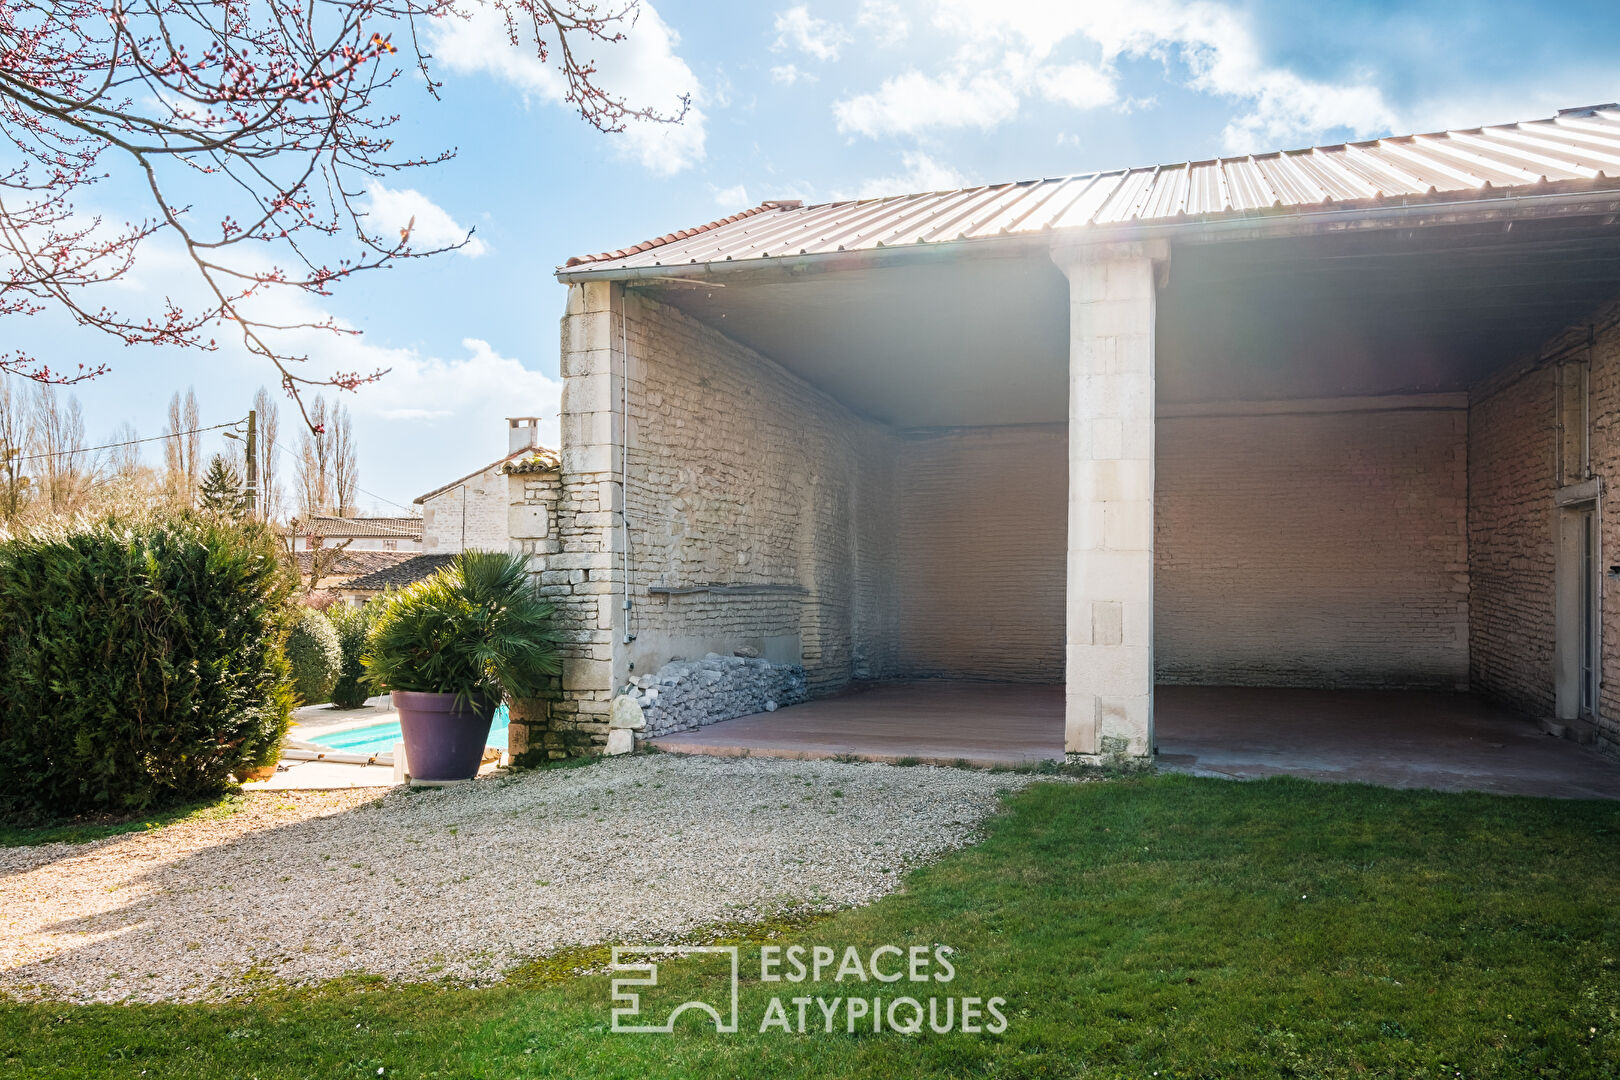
(0, 515, 292, 819)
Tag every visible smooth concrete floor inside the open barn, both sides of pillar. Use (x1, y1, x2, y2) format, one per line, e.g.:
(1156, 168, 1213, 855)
(653, 680, 1620, 798)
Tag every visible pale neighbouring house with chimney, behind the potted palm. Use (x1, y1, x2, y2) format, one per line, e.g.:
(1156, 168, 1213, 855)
(416, 416, 559, 555)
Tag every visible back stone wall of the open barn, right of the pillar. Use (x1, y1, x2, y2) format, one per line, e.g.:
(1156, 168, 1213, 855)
(1153, 397, 1469, 688)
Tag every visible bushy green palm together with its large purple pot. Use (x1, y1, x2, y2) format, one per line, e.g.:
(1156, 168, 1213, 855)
(361, 551, 562, 780)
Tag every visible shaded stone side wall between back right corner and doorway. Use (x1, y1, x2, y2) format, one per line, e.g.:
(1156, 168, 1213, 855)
(1468, 368, 1557, 716)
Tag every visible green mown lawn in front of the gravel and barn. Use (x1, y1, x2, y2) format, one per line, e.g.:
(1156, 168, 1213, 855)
(0, 777, 1620, 1080)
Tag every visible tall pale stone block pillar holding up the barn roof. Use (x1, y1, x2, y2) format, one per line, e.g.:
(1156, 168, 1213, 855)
(1051, 241, 1168, 763)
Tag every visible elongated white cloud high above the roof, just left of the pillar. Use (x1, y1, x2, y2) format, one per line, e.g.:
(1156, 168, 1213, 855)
(833, 71, 1019, 139)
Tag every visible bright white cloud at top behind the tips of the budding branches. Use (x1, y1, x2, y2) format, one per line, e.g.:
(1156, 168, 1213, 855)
(433, 3, 706, 176)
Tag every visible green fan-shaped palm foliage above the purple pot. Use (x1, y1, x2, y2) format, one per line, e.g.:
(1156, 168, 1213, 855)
(361, 551, 562, 708)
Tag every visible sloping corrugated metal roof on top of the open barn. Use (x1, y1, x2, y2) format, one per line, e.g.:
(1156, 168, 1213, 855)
(562, 105, 1620, 274)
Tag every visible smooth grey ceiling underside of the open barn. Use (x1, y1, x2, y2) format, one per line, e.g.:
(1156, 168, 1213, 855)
(637, 219, 1620, 427)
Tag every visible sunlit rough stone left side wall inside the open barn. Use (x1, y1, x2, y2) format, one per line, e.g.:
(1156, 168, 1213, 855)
(612, 286, 889, 693)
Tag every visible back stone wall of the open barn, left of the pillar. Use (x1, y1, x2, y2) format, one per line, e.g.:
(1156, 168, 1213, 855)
(889, 424, 1069, 683)
